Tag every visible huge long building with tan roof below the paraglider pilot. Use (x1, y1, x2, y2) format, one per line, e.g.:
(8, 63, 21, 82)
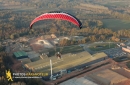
(25, 51, 107, 79)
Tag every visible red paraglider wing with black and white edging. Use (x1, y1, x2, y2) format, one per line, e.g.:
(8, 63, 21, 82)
(30, 12, 81, 29)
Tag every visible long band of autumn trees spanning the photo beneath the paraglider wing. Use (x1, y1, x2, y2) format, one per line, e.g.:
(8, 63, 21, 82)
(1, 24, 130, 41)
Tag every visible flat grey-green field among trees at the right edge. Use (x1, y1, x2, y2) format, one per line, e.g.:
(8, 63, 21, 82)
(102, 19, 130, 30)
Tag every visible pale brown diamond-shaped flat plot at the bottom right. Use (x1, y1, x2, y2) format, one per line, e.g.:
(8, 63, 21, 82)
(89, 69, 128, 85)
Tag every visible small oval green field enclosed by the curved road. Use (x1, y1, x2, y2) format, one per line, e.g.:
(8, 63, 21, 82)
(89, 43, 116, 51)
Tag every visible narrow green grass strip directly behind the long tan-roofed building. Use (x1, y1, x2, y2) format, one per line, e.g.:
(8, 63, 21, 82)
(49, 45, 84, 56)
